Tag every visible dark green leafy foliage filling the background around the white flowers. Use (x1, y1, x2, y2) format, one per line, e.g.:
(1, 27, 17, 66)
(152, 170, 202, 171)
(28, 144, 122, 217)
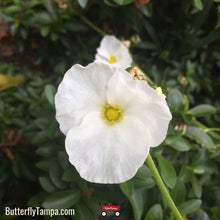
(0, 0, 220, 220)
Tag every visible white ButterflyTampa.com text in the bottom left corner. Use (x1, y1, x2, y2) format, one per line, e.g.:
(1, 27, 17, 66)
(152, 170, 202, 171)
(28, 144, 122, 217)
(5, 207, 75, 217)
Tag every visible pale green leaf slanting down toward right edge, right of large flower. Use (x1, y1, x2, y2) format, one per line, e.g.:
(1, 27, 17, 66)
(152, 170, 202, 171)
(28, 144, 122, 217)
(185, 126, 215, 149)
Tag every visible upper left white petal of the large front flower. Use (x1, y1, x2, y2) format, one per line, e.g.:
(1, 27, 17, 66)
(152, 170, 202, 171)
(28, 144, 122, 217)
(55, 63, 113, 134)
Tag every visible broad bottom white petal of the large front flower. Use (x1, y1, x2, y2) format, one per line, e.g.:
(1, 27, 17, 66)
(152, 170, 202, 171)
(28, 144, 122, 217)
(66, 113, 149, 183)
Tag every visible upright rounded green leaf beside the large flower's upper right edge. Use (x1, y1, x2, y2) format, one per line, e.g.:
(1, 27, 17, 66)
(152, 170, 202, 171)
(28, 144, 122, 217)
(167, 89, 184, 112)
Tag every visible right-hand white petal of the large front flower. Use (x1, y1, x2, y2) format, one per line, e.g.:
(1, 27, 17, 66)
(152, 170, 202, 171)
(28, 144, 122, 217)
(107, 69, 172, 147)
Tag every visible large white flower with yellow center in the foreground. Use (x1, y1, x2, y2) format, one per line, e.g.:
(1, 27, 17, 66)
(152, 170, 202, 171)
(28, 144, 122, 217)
(55, 63, 172, 183)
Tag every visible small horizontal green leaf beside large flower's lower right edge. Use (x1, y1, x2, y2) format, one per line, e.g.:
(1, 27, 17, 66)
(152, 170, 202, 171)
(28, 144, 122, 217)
(164, 136, 190, 151)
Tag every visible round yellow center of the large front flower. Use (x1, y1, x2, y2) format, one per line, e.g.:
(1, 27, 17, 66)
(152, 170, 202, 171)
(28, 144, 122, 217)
(101, 104, 123, 125)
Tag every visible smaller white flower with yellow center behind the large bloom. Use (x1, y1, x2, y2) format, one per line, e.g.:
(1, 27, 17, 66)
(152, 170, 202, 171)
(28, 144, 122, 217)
(95, 35, 132, 69)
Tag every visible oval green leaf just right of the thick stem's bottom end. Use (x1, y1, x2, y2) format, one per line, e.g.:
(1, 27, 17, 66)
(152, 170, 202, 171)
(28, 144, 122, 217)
(178, 199, 202, 214)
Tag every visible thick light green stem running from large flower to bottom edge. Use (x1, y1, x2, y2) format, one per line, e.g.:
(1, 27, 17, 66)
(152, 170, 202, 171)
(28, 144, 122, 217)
(146, 154, 183, 220)
